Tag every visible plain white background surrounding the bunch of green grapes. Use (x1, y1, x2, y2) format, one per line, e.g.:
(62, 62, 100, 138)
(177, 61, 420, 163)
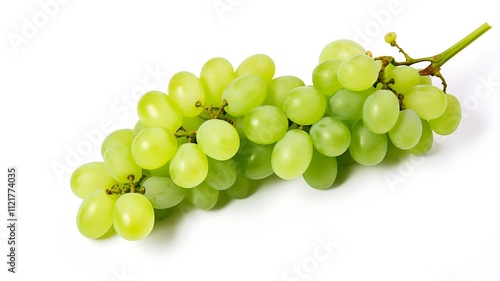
(0, 0, 500, 281)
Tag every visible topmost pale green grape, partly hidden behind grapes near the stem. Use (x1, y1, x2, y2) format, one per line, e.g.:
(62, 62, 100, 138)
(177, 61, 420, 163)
(319, 39, 366, 63)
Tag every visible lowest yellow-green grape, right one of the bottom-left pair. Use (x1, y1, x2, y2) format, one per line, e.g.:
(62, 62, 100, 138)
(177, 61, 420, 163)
(113, 193, 155, 241)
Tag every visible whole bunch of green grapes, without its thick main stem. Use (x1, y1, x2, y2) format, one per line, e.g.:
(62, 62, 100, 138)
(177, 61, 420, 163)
(70, 33, 472, 240)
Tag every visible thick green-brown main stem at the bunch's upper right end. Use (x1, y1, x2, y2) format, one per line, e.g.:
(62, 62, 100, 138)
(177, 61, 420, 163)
(375, 23, 491, 92)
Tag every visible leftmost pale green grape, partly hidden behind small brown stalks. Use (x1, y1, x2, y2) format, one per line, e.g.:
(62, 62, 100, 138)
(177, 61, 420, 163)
(69, 161, 118, 199)
